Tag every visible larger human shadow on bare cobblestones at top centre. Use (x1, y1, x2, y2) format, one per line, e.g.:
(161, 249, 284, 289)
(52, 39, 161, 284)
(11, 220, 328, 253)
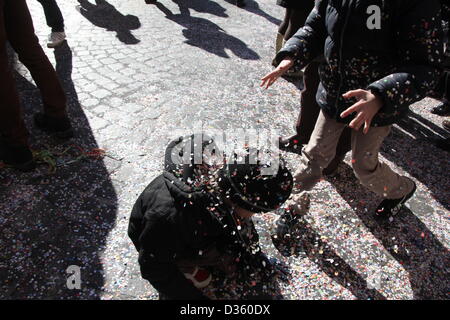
(156, 1, 259, 60)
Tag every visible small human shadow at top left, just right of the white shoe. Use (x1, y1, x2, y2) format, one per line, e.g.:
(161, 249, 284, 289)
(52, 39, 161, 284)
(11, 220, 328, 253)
(78, 0, 141, 44)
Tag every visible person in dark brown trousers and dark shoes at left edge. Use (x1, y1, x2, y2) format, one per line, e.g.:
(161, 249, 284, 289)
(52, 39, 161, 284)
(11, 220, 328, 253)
(0, 0, 73, 171)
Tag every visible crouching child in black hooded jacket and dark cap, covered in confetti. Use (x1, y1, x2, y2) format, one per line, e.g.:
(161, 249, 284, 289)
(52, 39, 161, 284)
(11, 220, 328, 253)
(128, 135, 293, 299)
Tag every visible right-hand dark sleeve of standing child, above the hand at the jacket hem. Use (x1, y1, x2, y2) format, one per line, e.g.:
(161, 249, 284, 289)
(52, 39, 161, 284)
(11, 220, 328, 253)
(368, 0, 444, 120)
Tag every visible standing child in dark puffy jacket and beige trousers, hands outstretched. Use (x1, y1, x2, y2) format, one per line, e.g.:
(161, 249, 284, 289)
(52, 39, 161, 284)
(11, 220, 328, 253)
(262, 0, 443, 218)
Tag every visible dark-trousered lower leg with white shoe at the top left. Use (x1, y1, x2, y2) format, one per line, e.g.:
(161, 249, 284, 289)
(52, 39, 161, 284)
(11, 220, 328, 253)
(37, 0, 66, 48)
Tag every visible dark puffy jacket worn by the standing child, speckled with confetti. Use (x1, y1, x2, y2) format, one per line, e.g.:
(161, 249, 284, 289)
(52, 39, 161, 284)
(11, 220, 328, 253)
(275, 0, 443, 126)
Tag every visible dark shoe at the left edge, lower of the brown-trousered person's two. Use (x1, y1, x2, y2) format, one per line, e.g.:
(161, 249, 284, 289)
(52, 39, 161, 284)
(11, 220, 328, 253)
(0, 142, 36, 172)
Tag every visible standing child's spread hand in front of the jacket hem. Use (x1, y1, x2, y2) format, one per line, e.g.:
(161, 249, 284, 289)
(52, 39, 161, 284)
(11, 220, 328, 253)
(341, 89, 383, 134)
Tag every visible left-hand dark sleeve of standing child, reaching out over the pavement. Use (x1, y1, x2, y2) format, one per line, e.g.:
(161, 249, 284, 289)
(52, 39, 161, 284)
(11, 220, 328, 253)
(275, 0, 327, 69)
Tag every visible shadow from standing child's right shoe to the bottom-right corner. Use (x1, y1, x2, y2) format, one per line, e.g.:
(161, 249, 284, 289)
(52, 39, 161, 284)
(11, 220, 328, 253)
(328, 164, 450, 300)
